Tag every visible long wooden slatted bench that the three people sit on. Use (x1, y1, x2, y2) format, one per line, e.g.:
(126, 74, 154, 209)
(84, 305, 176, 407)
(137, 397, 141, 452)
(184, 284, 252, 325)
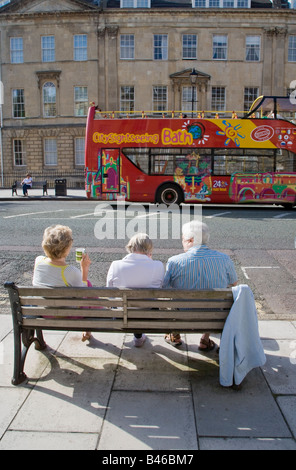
(4, 283, 233, 385)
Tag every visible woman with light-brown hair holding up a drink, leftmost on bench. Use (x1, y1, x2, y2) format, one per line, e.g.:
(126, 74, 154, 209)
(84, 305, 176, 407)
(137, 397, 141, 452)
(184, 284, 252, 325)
(33, 225, 91, 341)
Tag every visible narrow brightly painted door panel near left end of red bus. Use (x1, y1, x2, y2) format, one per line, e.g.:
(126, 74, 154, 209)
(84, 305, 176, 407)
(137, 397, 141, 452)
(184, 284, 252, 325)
(101, 149, 120, 193)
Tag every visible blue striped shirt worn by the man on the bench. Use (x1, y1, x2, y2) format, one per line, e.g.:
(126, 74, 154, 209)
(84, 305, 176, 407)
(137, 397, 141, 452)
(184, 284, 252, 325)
(163, 245, 237, 290)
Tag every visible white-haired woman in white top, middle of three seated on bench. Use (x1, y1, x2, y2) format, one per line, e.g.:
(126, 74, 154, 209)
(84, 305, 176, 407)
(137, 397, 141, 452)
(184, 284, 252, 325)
(107, 233, 164, 347)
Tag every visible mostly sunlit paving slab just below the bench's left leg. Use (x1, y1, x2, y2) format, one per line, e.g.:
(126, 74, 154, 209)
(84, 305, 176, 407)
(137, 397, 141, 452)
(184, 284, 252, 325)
(9, 356, 116, 433)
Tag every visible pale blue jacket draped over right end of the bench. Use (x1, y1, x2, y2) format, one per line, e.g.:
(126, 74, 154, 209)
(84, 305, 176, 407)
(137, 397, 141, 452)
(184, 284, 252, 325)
(219, 284, 266, 387)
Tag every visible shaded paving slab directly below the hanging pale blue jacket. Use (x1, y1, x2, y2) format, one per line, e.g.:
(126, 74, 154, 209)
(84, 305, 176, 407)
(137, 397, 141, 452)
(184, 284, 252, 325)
(192, 368, 292, 438)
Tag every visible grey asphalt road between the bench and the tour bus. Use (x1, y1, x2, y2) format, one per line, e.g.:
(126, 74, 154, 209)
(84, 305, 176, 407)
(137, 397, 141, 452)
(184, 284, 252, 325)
(0, 200, 296, 319)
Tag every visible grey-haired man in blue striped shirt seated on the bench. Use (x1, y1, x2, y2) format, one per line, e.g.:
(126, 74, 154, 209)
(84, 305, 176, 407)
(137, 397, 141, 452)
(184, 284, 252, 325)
(163, 220, 237, 351)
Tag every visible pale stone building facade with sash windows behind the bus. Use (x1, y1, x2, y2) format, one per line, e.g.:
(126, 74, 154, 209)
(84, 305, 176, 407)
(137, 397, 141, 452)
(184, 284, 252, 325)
(0, 0, 296, 186)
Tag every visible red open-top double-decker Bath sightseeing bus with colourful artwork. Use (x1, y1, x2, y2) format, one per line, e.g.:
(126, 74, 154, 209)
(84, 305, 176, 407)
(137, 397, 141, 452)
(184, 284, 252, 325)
(85, 97, 296, 208)
